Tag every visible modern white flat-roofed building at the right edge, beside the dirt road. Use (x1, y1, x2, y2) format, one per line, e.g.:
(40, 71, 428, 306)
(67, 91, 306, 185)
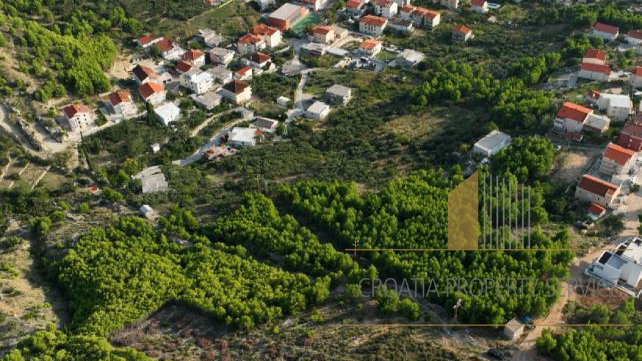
(588, 237, 642, 288)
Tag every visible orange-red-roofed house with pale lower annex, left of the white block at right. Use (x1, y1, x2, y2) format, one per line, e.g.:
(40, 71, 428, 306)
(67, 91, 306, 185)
(553, 102, 611, 133)
